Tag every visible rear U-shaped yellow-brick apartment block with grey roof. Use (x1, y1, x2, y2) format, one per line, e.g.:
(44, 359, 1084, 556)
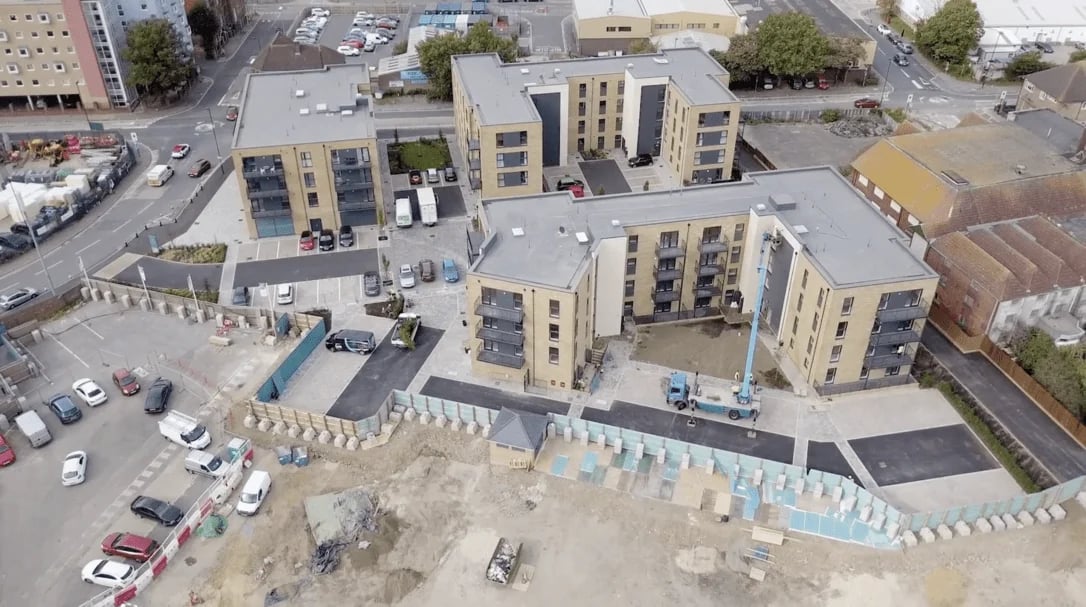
(453, 48, 740, 199)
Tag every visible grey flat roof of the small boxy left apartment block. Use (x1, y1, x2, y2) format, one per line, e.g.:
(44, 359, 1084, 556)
(233, 64, 377, 149)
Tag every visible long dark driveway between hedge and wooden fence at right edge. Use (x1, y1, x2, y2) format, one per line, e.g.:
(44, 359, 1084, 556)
(922, 328, 1086, 482)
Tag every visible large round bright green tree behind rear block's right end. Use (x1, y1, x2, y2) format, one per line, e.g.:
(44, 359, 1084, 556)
(755, 12, 830, 76)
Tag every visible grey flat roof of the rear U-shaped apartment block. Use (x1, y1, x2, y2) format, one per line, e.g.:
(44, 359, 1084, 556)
(453, 48, 737, 125)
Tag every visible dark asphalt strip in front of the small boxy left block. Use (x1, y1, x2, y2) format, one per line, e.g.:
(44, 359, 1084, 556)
(233, 249, 378, 287)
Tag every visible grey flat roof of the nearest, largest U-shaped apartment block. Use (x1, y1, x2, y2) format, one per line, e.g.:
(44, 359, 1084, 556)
(471, 166, 936, 289)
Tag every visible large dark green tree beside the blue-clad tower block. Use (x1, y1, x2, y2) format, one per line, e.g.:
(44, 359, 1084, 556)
(121, 18, 193, 97)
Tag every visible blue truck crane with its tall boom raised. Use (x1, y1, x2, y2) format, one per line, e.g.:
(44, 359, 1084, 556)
(668, 232, 774, 419)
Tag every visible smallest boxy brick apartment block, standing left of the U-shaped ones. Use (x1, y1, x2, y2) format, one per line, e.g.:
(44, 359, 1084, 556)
(231, 65, 381, 238)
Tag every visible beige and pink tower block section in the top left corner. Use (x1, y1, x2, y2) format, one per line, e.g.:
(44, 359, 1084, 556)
(0, 0, 110, 110)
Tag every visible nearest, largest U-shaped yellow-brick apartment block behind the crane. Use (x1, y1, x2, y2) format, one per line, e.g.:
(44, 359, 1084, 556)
(467, 167, 938, 393)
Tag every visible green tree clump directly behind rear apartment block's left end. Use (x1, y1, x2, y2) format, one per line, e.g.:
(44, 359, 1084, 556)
(417, 22, 517, 101)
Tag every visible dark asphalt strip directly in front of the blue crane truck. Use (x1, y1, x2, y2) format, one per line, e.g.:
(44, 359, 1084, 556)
(581, 401, 795, 464)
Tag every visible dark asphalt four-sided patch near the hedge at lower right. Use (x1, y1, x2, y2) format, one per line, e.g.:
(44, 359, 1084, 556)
(848, 423, 999, 486)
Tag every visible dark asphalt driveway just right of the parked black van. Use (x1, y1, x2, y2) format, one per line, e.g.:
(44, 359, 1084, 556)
(326, 325, 445, 421)
